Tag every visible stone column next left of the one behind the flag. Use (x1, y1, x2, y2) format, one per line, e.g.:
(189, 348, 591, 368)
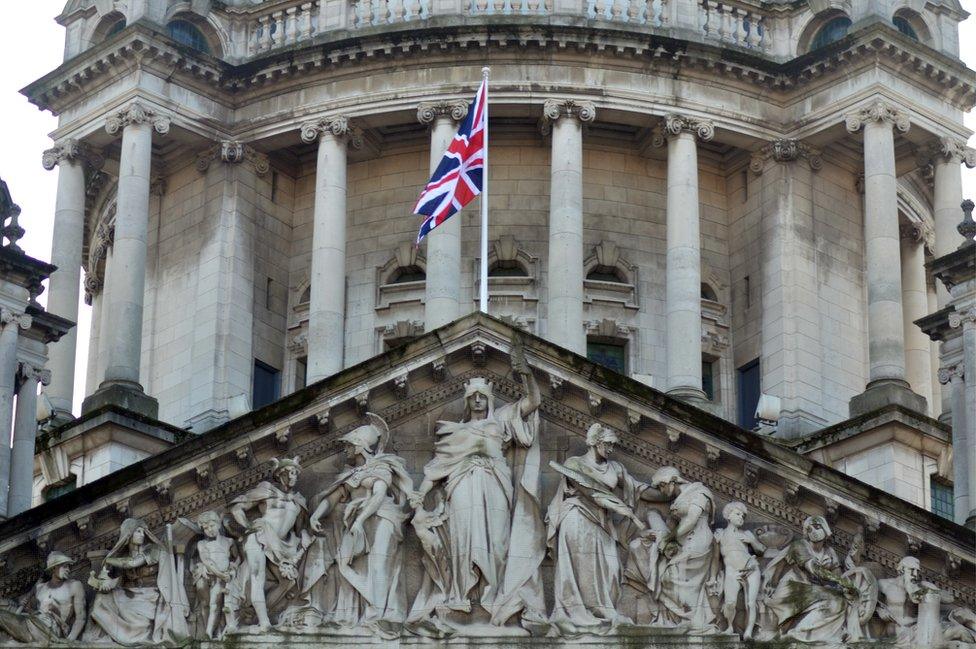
(302, 115, 362, 384)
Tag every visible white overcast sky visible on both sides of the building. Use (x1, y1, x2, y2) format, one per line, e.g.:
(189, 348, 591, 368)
(0, 0, 976, 413)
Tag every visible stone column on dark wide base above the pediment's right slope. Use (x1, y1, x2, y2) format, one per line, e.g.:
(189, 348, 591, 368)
(846, 100, 927, 416)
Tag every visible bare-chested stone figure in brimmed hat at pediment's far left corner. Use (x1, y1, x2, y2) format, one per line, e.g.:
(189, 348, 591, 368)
(0, 552, 86, 644)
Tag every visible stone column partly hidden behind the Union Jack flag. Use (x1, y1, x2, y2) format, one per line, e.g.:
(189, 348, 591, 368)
(417, 100, 469, 331)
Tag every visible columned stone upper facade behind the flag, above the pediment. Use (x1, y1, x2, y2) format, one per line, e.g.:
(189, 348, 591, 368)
(24, 0, 976, 523)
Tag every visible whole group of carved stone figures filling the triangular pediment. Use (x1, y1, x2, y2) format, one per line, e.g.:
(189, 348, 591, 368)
(0, 354, 976, 648)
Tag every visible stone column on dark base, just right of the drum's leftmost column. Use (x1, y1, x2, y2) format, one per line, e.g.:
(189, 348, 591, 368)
(82, 103, 170, 418)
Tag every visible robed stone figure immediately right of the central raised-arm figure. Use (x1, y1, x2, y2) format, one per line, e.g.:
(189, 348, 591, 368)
(546, 424, 661, 633)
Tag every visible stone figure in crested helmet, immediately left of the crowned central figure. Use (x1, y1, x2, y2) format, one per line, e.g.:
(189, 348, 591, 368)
(303, 413, 413, 635)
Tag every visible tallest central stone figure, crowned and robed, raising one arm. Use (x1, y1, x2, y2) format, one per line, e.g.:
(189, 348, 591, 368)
(409, 352, 545, 630)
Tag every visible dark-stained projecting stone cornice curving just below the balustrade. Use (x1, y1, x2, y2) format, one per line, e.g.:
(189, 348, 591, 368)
(21, 16, 976, 130)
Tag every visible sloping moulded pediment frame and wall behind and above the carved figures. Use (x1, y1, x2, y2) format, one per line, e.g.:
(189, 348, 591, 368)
(0, 314, 976, 644)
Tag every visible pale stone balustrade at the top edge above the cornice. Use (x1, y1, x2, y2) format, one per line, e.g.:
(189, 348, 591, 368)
(228, 0, 773, 59)
